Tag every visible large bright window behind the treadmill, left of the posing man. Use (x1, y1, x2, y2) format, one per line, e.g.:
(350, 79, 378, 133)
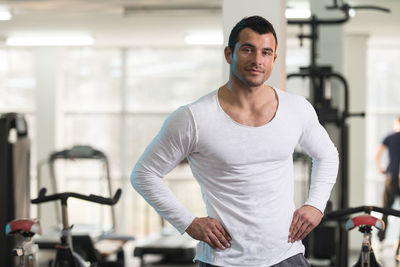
(59, 47, 223, 235)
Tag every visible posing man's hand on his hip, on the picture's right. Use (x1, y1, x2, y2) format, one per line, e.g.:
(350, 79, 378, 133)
(289, 205, 322, 243)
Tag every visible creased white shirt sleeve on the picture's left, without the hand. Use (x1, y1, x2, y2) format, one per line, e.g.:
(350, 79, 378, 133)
(131, 106, 196, 233)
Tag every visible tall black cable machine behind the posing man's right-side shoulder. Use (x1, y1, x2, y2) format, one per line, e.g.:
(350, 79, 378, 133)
(287, 0, 390, 267)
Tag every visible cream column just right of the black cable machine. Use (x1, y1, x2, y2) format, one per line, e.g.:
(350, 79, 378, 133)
(344, 34, 368, 250)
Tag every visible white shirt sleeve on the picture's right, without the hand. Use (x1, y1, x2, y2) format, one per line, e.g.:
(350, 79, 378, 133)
(299, 100, 339, 213)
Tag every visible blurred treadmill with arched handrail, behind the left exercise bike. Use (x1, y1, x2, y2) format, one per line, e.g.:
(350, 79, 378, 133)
(36, 145, 134, 266)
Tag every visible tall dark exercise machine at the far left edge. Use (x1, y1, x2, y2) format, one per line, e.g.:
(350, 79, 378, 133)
(0, 113, 30, 267)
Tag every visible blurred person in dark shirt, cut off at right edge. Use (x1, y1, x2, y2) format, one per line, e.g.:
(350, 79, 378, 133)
(375, 117, 400, 241)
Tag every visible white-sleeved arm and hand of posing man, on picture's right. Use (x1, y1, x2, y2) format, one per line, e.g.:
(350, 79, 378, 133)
(288, 99, 339, 242)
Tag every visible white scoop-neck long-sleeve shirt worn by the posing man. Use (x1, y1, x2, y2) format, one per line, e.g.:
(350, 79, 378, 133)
(131, 89, 338, 267)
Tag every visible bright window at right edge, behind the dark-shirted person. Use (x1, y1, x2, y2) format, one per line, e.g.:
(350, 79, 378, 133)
(366, 44, 400, 205)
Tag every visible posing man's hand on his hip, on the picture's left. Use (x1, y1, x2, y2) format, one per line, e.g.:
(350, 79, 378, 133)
(186, 217, 232, 249)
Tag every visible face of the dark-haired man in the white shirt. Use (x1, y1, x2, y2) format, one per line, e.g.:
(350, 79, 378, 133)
(225, 28, 276, 87)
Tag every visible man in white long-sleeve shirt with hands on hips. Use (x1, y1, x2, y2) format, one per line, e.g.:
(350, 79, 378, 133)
(131, 16, 338, 267)
